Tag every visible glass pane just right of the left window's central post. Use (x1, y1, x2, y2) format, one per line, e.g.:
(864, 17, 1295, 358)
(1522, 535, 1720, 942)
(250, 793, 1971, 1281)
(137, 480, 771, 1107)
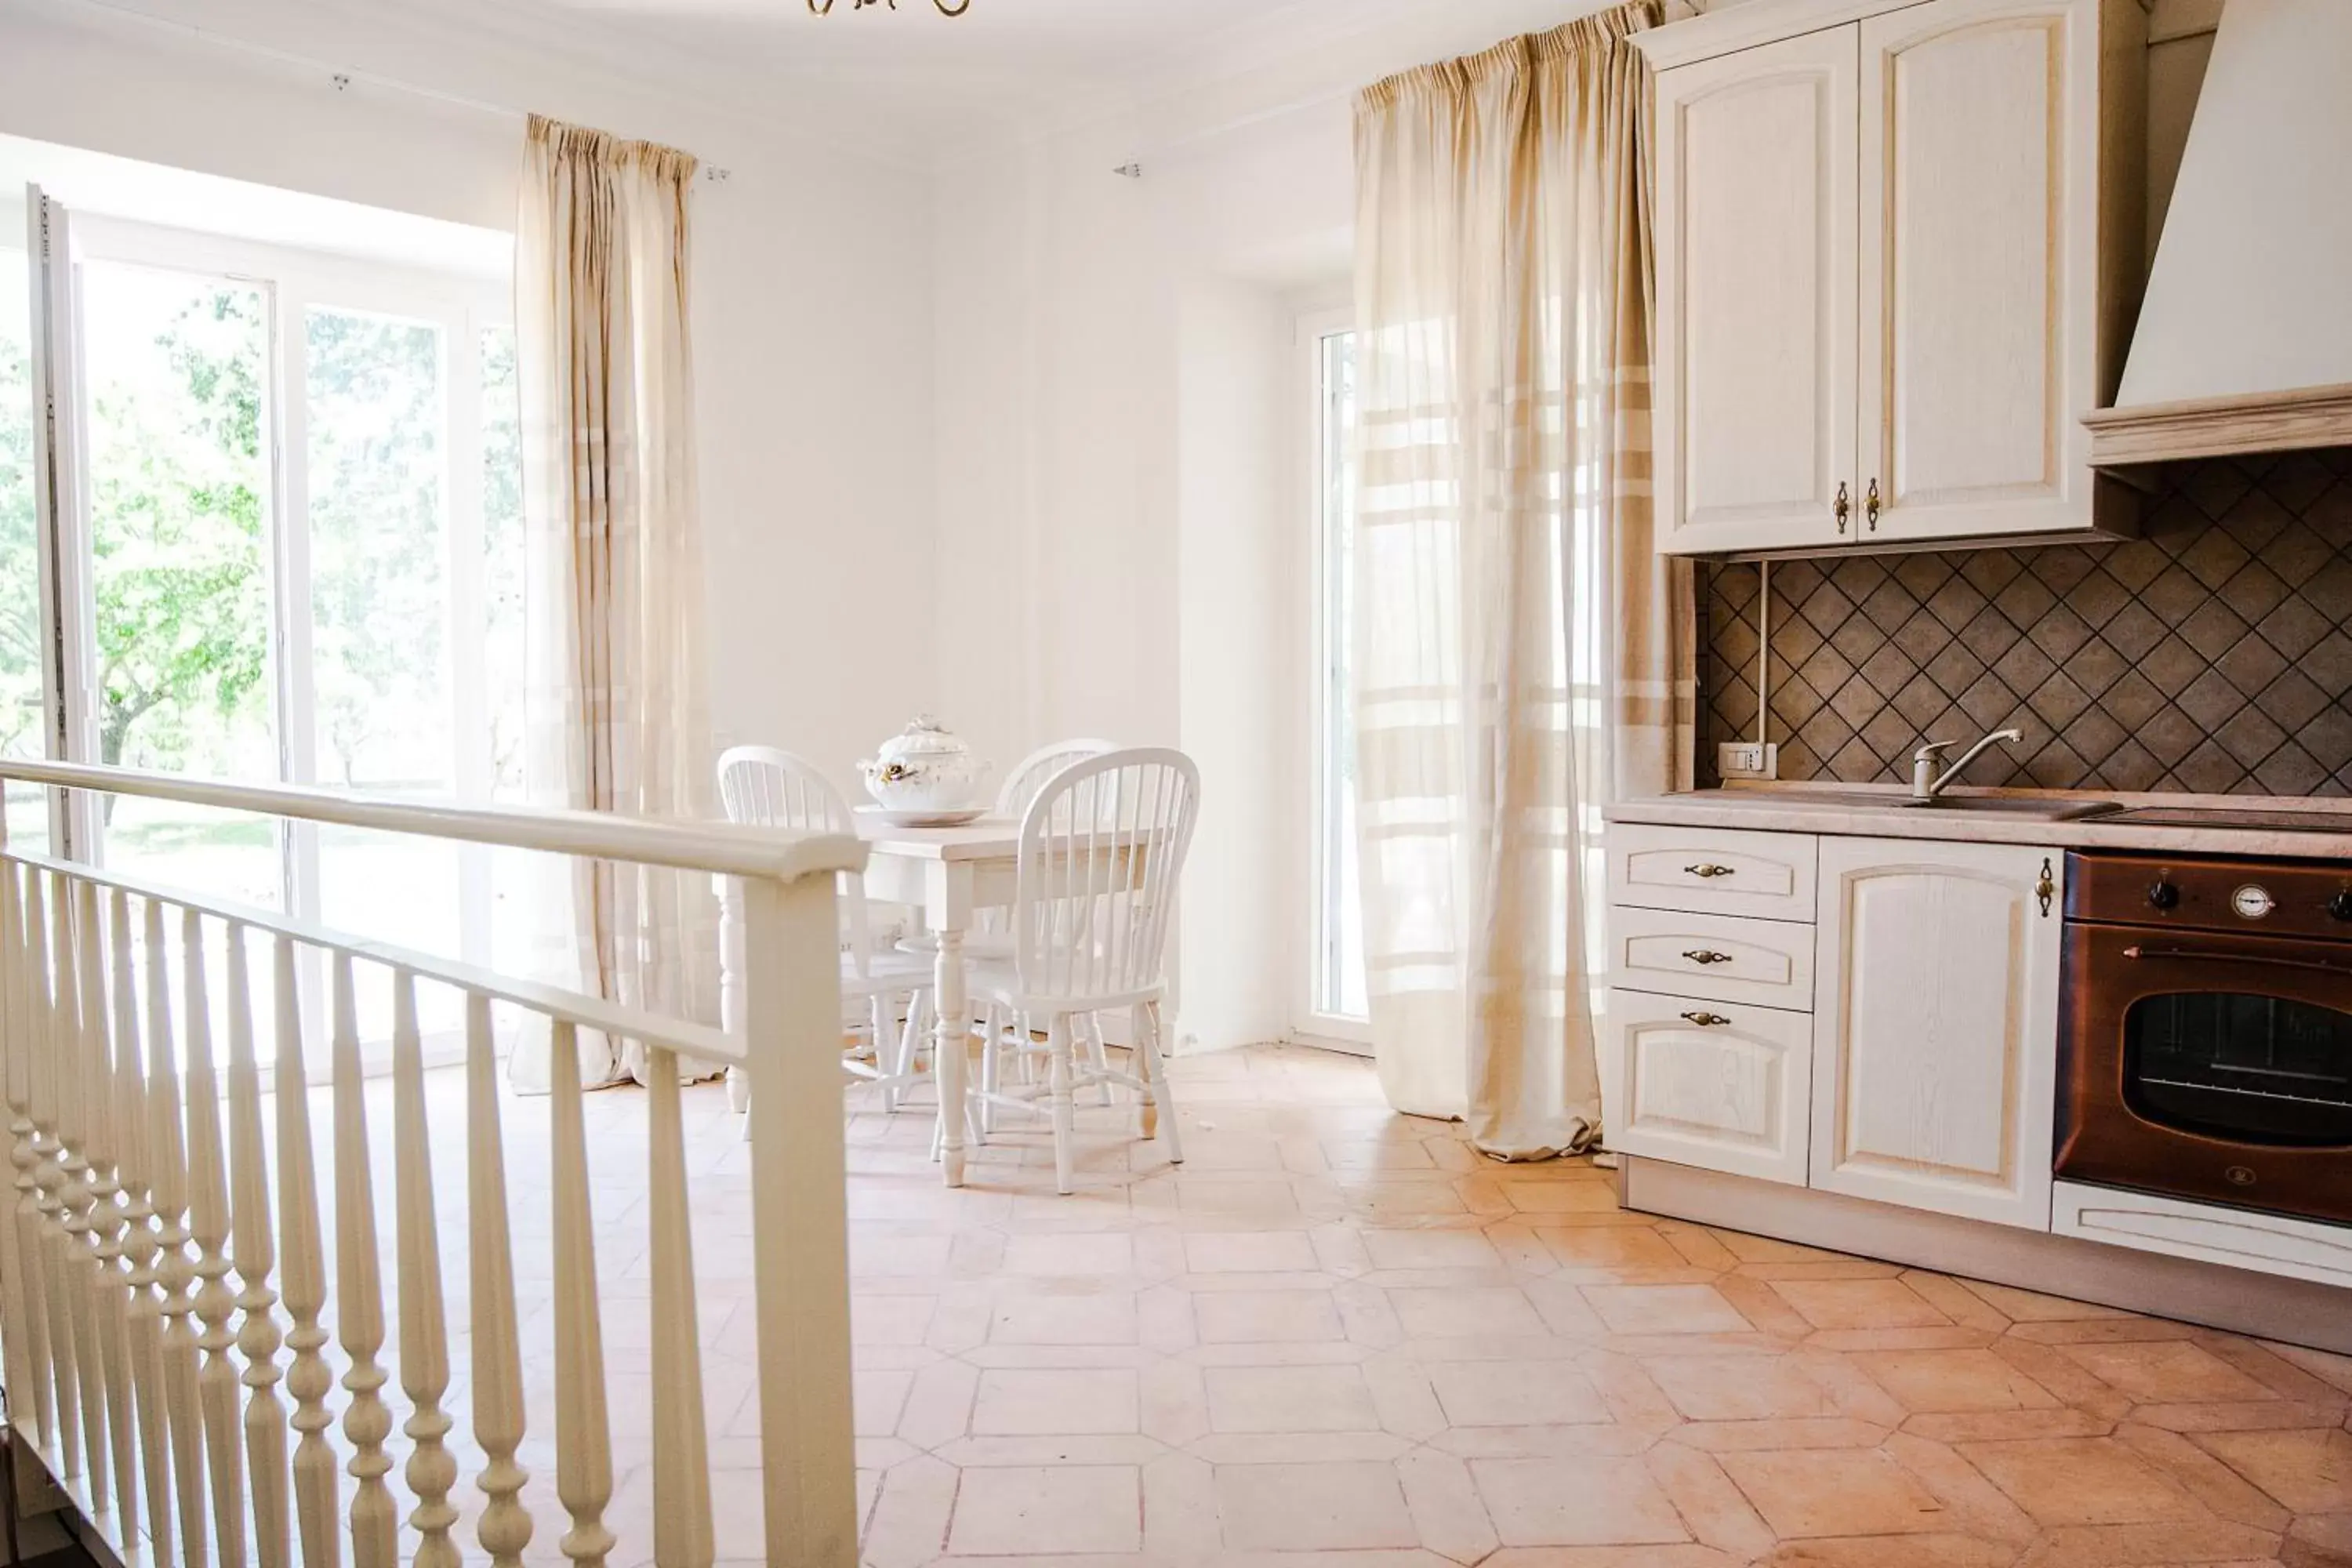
(303, 308, 461, 1039)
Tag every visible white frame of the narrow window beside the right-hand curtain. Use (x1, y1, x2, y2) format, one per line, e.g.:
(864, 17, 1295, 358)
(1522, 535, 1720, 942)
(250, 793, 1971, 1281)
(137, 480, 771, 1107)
(1291, 308, 1371, 1055)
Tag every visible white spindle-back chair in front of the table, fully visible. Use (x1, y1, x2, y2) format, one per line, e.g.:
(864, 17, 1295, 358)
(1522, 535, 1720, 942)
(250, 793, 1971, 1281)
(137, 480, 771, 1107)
(974, 750, 1200, 1192)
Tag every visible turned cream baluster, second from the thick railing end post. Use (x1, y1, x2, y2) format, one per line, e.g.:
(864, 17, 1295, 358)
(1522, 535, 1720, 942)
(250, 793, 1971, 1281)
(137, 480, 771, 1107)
(548, 1020, 614, 1568)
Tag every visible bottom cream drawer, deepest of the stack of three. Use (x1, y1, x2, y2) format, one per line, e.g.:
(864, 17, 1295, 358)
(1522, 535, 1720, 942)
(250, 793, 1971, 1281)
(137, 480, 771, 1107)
(1602, 989, 1813, 1187)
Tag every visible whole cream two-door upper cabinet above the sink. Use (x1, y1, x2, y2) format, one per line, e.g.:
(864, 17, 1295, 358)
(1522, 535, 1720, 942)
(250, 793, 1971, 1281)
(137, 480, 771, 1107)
(1639, 0, 2147, 555)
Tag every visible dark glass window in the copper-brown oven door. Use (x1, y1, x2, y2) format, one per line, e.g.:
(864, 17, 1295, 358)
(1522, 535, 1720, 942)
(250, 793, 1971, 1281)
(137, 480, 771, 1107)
(2124, 992, 2352, 1147)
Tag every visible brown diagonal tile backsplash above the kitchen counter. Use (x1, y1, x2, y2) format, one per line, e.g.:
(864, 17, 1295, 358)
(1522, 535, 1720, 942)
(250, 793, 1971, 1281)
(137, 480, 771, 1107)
(1698, 449, 2352, 794)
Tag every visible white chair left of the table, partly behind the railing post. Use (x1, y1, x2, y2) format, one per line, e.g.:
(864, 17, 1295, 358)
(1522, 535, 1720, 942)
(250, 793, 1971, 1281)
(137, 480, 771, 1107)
(720, 746, 931, 1112)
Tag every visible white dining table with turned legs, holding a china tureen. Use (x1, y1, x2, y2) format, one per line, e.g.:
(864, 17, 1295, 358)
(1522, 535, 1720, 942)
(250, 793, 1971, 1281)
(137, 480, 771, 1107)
(858, 811, 1021, 1187)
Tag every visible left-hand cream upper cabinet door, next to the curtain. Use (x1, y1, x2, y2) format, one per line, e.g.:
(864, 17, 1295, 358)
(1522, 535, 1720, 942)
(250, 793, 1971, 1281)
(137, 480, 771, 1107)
(1653, 26, 1858, 555)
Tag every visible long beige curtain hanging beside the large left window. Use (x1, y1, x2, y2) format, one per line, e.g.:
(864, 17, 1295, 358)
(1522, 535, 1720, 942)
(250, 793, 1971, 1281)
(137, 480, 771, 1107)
(513, 115, 717, 1088)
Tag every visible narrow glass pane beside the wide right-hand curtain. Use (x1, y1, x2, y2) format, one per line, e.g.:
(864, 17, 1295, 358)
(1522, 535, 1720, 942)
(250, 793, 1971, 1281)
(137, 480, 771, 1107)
(1315, 332, 1371, 1018)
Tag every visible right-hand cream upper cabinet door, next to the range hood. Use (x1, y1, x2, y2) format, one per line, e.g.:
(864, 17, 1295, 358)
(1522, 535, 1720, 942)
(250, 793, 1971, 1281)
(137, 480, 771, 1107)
(1856, 0, 2100, 543)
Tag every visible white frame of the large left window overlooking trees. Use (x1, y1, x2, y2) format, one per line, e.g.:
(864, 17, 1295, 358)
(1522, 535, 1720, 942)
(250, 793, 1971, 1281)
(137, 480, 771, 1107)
(52, 214, 515, 1065)
